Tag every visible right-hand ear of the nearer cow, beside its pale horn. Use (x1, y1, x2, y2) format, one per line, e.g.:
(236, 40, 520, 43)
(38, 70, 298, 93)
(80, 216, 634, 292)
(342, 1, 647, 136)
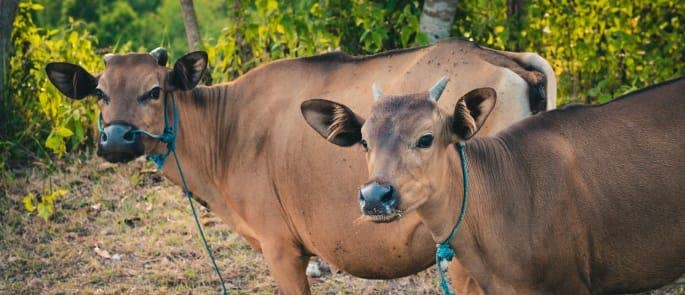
(450, 87, 497, 140)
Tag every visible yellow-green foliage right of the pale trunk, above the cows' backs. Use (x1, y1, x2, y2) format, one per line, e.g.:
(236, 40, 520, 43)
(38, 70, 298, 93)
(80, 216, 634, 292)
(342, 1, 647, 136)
(453, 0, 685, 103)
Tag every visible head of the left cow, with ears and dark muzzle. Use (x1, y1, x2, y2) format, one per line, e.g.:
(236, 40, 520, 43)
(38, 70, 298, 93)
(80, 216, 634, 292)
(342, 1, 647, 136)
(45, 48, 207, 162)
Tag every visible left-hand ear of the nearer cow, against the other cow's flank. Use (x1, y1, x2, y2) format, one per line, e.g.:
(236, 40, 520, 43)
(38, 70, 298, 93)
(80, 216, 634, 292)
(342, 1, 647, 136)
(300, 99, 364, 146)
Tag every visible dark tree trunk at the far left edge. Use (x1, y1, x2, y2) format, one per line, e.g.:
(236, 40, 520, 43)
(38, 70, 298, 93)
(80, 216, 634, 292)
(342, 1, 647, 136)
(0, 0, 19, 111)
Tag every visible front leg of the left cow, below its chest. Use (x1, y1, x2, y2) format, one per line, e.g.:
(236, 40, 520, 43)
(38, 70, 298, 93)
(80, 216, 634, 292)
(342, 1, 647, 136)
(262, 241, 311, 295)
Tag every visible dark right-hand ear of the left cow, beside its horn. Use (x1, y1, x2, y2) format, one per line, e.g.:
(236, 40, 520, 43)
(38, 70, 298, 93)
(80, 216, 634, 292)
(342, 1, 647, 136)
(167, 51, 207, 90)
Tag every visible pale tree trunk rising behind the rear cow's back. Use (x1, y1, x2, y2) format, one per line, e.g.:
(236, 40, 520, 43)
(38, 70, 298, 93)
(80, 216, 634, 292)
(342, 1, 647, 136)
(419, 0, 457, 43)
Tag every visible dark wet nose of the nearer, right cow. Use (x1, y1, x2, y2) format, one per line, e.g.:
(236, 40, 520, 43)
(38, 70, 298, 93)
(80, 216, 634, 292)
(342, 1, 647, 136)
(359, 182, 397, 215)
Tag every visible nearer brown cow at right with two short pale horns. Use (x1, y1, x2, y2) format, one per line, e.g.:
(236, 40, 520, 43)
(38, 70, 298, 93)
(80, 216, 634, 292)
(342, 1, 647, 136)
(303, 78, 685, 294)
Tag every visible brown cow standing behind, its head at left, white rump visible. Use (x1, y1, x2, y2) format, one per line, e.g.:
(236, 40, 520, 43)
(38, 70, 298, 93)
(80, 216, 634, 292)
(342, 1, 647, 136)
(47, 40, 556, 294)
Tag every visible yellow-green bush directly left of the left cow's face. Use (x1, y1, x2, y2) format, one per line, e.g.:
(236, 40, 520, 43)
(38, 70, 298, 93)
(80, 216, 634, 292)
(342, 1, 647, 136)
(0, 2, 103, 169)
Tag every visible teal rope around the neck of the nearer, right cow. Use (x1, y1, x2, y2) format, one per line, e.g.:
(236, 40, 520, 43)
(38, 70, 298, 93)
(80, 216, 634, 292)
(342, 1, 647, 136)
(435, 142, 469, 295)
